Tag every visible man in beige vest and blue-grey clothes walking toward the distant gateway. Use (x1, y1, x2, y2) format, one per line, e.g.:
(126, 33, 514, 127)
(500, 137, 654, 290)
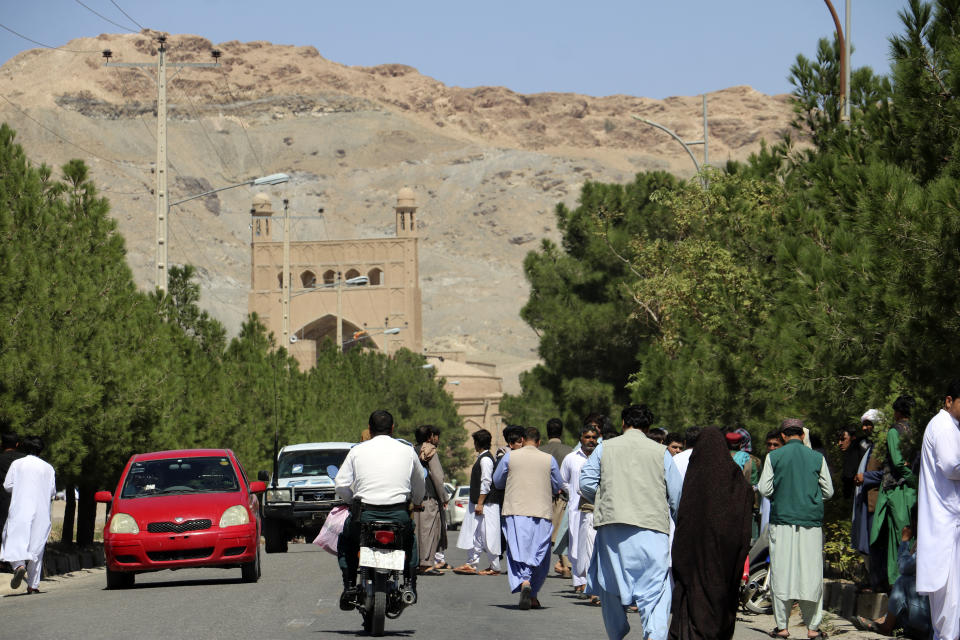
(493, 427, 563, 610)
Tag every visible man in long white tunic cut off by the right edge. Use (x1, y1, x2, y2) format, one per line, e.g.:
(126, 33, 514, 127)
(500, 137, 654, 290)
(917, 380, 960, 640)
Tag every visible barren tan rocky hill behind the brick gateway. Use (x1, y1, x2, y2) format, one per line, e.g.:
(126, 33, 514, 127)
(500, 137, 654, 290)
(0, 32, 791, 389)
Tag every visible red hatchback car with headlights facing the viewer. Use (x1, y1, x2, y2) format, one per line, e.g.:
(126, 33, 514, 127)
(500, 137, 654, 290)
(96, 449, 267, 589)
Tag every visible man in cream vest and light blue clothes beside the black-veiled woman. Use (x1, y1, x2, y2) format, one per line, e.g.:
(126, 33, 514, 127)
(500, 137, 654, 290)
(580, 405, 683, 640)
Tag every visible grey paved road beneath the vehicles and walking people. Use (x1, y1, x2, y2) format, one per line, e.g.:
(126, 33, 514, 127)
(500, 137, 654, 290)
(0, 545, 880, 640)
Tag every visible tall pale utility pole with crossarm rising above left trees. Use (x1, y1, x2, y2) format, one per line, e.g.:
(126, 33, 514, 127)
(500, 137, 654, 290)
(103, 36, 220, 295)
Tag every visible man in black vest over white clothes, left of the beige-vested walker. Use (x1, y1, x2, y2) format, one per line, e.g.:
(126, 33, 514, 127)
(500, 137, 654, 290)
(453, 429, 503, 575)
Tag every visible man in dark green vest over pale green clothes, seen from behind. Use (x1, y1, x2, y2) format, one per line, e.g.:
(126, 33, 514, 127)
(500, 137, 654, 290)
(758, 418, 833, 638)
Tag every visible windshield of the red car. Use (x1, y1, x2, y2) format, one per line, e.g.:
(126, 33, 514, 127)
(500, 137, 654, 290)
(120, 456, 240, 498)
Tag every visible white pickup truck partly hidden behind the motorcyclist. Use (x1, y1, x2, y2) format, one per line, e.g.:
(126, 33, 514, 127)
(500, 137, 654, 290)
(260, 442, 355, 553)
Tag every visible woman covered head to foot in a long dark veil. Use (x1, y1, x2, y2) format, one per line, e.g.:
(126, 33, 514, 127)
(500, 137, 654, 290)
(670, 427, 753, 640)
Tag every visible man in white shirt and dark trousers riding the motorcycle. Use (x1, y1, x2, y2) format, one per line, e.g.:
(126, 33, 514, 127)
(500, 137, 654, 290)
(335, 410, 425, 611)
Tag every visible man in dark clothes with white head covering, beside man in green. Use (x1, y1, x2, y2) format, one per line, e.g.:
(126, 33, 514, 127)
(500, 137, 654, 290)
(850, 409, 887, 591)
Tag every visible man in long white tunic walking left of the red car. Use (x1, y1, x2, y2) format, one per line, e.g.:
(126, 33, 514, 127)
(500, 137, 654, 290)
(0, 437, 57, 593)
